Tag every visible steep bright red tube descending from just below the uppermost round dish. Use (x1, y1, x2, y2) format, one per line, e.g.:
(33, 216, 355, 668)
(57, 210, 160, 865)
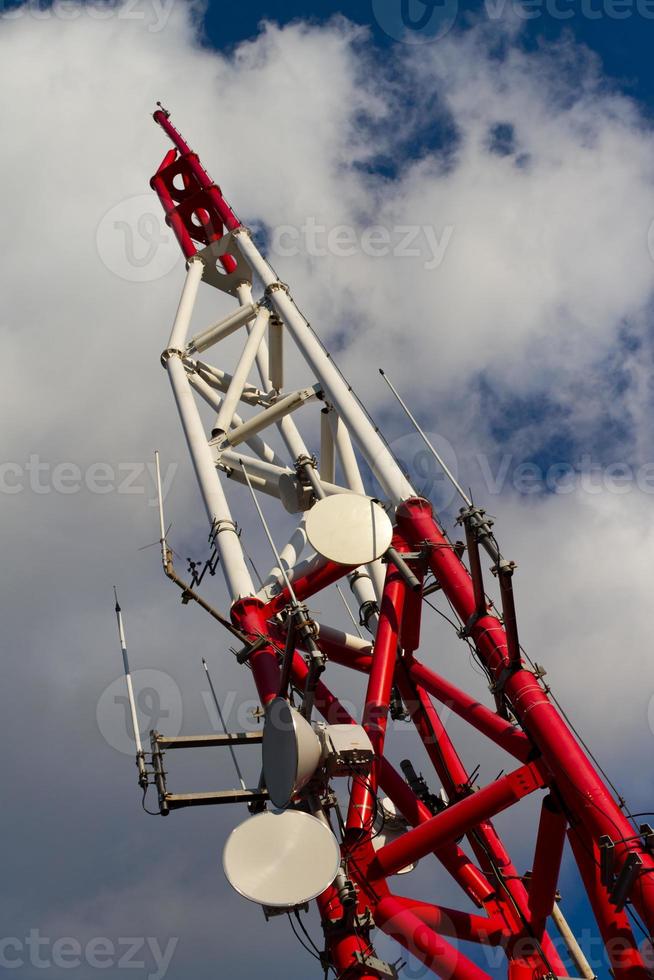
(347, 564, 407, 833)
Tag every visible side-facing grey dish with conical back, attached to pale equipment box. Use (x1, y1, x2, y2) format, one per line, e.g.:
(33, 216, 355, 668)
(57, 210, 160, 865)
(262, 698, 322, 809)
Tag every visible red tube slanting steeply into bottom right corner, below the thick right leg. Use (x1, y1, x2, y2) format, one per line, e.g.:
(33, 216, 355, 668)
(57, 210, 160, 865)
(568, 828, 649, 980)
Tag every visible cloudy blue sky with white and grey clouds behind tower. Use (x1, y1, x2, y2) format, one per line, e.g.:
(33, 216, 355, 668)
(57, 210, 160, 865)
(0, 0, 654, 980)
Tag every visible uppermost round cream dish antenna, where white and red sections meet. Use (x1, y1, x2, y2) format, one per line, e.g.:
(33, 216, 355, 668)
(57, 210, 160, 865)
(306, 493, 393, 566)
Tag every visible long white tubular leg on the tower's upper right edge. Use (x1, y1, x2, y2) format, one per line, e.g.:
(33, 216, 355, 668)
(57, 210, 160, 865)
(235, 228, 416, 505)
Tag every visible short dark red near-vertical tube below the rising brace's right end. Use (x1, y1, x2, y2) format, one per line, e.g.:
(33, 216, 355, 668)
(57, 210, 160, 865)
(529, 795, 568, 938)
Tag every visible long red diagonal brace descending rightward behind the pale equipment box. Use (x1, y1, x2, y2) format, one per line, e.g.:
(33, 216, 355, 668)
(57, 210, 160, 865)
(293, 654, 494, 908)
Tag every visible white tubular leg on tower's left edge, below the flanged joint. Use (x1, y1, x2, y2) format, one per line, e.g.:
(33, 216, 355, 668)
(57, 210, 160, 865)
(166, 353, 254, 600)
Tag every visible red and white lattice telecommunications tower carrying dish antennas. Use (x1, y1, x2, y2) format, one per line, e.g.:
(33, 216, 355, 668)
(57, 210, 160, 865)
(142, 109, 654, 980)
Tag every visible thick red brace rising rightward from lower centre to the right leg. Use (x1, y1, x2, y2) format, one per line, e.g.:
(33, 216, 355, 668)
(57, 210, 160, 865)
(370, 764, 544, 878)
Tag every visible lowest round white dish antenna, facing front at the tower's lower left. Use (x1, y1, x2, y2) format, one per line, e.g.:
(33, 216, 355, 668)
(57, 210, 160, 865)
(223, 810, 341, 908)
